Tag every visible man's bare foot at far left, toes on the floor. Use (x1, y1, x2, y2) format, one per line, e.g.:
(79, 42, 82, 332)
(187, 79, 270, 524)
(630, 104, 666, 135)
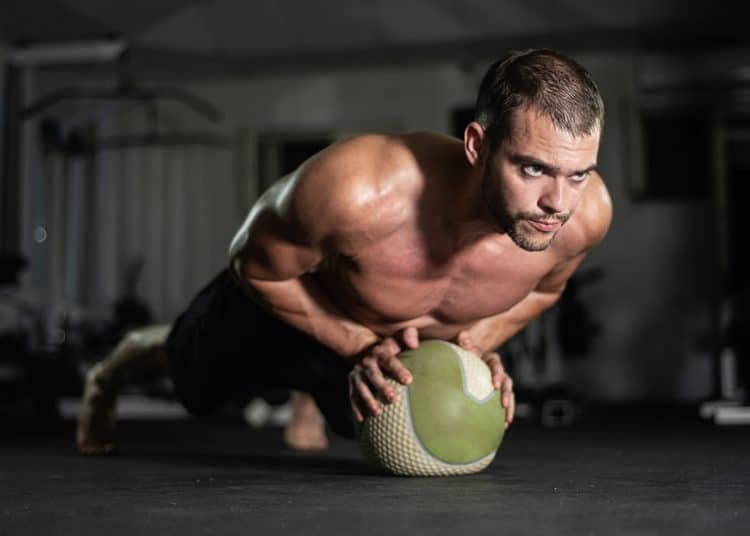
(76, 365, 117, 455)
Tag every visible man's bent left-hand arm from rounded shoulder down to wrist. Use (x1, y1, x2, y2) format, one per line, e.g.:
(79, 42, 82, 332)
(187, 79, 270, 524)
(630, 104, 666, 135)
(230, 136, 418, 356)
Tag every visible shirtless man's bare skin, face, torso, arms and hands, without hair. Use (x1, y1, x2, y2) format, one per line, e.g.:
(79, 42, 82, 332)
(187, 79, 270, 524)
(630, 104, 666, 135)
(231, 109, 612, 428)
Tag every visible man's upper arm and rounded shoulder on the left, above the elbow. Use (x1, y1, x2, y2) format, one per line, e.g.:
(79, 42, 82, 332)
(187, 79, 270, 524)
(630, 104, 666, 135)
(231, 138, 392, 281)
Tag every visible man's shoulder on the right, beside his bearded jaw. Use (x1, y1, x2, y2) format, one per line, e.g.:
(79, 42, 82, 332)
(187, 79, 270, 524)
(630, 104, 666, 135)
(555, 173, 612, 257)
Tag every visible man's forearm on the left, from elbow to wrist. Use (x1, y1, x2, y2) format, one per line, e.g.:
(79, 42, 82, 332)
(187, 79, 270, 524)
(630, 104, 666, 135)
(235, 262, 380, 357)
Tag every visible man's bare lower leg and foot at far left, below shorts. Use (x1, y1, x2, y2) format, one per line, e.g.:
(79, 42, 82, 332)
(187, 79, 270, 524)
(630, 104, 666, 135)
(76, 326, 170, 454)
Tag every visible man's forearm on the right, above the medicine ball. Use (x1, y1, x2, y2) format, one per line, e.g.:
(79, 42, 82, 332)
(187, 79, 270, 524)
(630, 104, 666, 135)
(468, 291, 561, 351)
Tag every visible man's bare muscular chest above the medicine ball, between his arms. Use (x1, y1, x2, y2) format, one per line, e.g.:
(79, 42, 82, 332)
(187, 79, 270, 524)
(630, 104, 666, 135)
(337, 229, 551, 324)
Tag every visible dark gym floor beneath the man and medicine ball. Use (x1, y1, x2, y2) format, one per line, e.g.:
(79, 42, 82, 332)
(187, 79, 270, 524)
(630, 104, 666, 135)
(0, 406, 750, 536)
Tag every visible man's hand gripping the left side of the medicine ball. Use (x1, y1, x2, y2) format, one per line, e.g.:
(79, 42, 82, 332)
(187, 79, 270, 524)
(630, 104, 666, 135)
(349, 328, 419, 422)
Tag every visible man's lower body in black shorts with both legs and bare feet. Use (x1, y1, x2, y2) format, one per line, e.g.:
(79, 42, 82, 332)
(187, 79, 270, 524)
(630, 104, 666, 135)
(76, 272, 350, 454)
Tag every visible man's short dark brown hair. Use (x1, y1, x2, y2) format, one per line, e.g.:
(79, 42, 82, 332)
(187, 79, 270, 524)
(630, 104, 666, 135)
(474, 49, 604, 146)
